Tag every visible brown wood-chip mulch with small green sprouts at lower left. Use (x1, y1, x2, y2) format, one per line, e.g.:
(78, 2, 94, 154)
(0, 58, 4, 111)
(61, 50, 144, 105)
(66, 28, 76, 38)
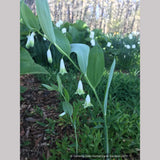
(20, 75, 73, 160)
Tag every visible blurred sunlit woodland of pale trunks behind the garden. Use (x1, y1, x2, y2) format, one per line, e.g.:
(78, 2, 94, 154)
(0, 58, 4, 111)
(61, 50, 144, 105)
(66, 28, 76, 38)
(25, 0, 140, 34)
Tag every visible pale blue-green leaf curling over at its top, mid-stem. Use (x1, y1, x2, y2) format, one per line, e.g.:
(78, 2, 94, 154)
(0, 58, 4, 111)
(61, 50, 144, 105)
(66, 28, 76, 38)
(71, 43, 90, 74)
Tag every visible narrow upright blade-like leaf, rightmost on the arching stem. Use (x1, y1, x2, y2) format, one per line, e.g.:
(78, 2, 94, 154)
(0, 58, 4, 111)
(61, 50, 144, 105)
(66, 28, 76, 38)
(104, 59, 116, 115)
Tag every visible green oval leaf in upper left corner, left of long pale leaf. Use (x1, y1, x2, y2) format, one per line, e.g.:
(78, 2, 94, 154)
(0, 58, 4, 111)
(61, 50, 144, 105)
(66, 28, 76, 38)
(20, 2, 40, 30)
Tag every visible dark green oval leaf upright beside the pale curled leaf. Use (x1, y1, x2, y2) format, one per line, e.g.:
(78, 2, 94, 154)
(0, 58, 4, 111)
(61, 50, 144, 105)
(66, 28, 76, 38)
(87, 46, 105, 88)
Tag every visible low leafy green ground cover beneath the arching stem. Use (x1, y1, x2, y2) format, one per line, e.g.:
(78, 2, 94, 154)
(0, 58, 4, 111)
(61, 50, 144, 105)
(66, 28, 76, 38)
(35, 71, 140, 158)
